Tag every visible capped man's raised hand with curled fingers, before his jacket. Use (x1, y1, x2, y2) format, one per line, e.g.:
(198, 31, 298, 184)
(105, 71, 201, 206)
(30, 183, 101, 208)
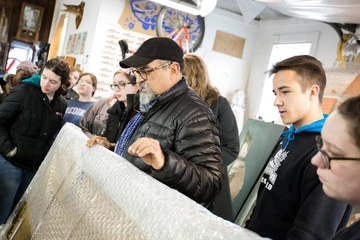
(128, 137, 165, 170)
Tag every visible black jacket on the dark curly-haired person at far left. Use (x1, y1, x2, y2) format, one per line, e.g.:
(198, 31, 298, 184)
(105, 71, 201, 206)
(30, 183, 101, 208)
(0, 82, 67, 170)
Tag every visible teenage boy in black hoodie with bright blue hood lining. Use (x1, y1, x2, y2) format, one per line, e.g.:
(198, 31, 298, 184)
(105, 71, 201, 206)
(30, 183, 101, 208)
(246, 55, 351, 240)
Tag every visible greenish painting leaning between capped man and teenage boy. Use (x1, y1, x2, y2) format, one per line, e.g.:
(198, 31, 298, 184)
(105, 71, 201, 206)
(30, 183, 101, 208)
(228, 118, 286, 226)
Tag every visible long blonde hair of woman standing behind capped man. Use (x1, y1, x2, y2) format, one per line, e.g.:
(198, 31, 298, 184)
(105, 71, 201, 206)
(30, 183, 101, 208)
(184, 53, 220, 107)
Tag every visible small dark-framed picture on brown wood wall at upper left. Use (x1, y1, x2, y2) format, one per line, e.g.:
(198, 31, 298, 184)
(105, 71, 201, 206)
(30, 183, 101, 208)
(16, 3, 44, 43)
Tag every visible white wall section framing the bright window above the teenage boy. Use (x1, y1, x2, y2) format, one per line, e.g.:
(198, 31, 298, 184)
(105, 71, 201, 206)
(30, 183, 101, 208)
(245, 18, 339, 119)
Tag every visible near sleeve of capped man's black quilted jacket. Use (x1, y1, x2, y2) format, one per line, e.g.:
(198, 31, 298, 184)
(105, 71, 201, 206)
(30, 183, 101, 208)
(152, 107, 224, 208)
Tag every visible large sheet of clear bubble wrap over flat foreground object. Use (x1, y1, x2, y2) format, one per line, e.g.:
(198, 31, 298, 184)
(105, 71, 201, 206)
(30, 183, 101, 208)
(0, 123, 262, 240)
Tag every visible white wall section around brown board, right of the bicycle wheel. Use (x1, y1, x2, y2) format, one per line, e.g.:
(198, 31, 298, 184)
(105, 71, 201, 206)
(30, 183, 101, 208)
(196, 7, 259, 101)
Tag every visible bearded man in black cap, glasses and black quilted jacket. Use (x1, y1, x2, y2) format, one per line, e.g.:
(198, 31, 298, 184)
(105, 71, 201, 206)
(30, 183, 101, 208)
(115, 37, 224, 209)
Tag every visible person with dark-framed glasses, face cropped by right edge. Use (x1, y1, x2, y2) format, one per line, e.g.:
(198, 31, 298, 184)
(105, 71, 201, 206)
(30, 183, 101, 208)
(311, 96, 360, 240)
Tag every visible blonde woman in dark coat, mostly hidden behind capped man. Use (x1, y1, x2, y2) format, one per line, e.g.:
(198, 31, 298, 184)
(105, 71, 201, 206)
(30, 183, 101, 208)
(184, 53, 240, 222)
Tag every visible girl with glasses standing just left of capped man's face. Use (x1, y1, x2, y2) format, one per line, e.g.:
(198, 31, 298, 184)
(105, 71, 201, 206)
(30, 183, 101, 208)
(85, 69, 138, 150)
